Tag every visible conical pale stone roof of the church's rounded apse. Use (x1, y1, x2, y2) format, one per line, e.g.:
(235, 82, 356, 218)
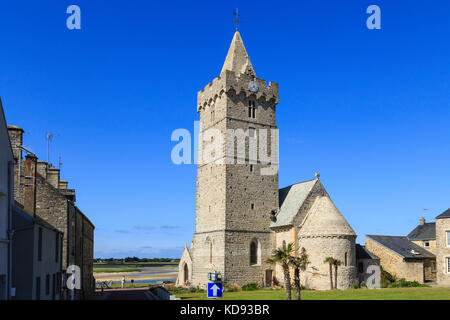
(298, 196, 356, 236)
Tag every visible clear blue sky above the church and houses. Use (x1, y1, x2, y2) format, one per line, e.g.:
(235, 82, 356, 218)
(0, 0, 450, 257)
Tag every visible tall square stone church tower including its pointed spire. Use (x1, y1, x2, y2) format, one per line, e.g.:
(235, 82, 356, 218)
(189, 31, 278, 286)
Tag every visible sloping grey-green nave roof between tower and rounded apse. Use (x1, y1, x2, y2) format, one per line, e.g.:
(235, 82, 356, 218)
(270, 179, 317, 228)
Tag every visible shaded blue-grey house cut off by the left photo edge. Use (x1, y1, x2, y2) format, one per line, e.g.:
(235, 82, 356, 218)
(0, 99, 14, 300)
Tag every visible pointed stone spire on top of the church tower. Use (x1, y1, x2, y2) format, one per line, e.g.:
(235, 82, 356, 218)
(220, 31, 255, 76)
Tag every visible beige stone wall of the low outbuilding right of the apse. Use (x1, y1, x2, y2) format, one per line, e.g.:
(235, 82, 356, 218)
(366, 237, 425, 283)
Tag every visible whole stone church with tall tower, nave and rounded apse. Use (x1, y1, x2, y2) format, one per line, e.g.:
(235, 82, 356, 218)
(177, 31, 357, 290)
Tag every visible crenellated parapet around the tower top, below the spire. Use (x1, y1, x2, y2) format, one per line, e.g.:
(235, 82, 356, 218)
(197, 70, 278, 112)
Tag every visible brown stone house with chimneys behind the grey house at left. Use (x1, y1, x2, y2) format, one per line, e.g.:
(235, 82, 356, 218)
(8, 126, 95, 299)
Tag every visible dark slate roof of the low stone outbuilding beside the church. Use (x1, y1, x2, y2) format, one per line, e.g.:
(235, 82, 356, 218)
(367, 235, 436, 259)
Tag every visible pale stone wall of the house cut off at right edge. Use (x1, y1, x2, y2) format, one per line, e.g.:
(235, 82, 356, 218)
(436, 218, 450, 285)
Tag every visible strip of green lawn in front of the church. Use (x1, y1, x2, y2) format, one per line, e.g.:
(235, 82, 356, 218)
(169, 287, 450, 300)
